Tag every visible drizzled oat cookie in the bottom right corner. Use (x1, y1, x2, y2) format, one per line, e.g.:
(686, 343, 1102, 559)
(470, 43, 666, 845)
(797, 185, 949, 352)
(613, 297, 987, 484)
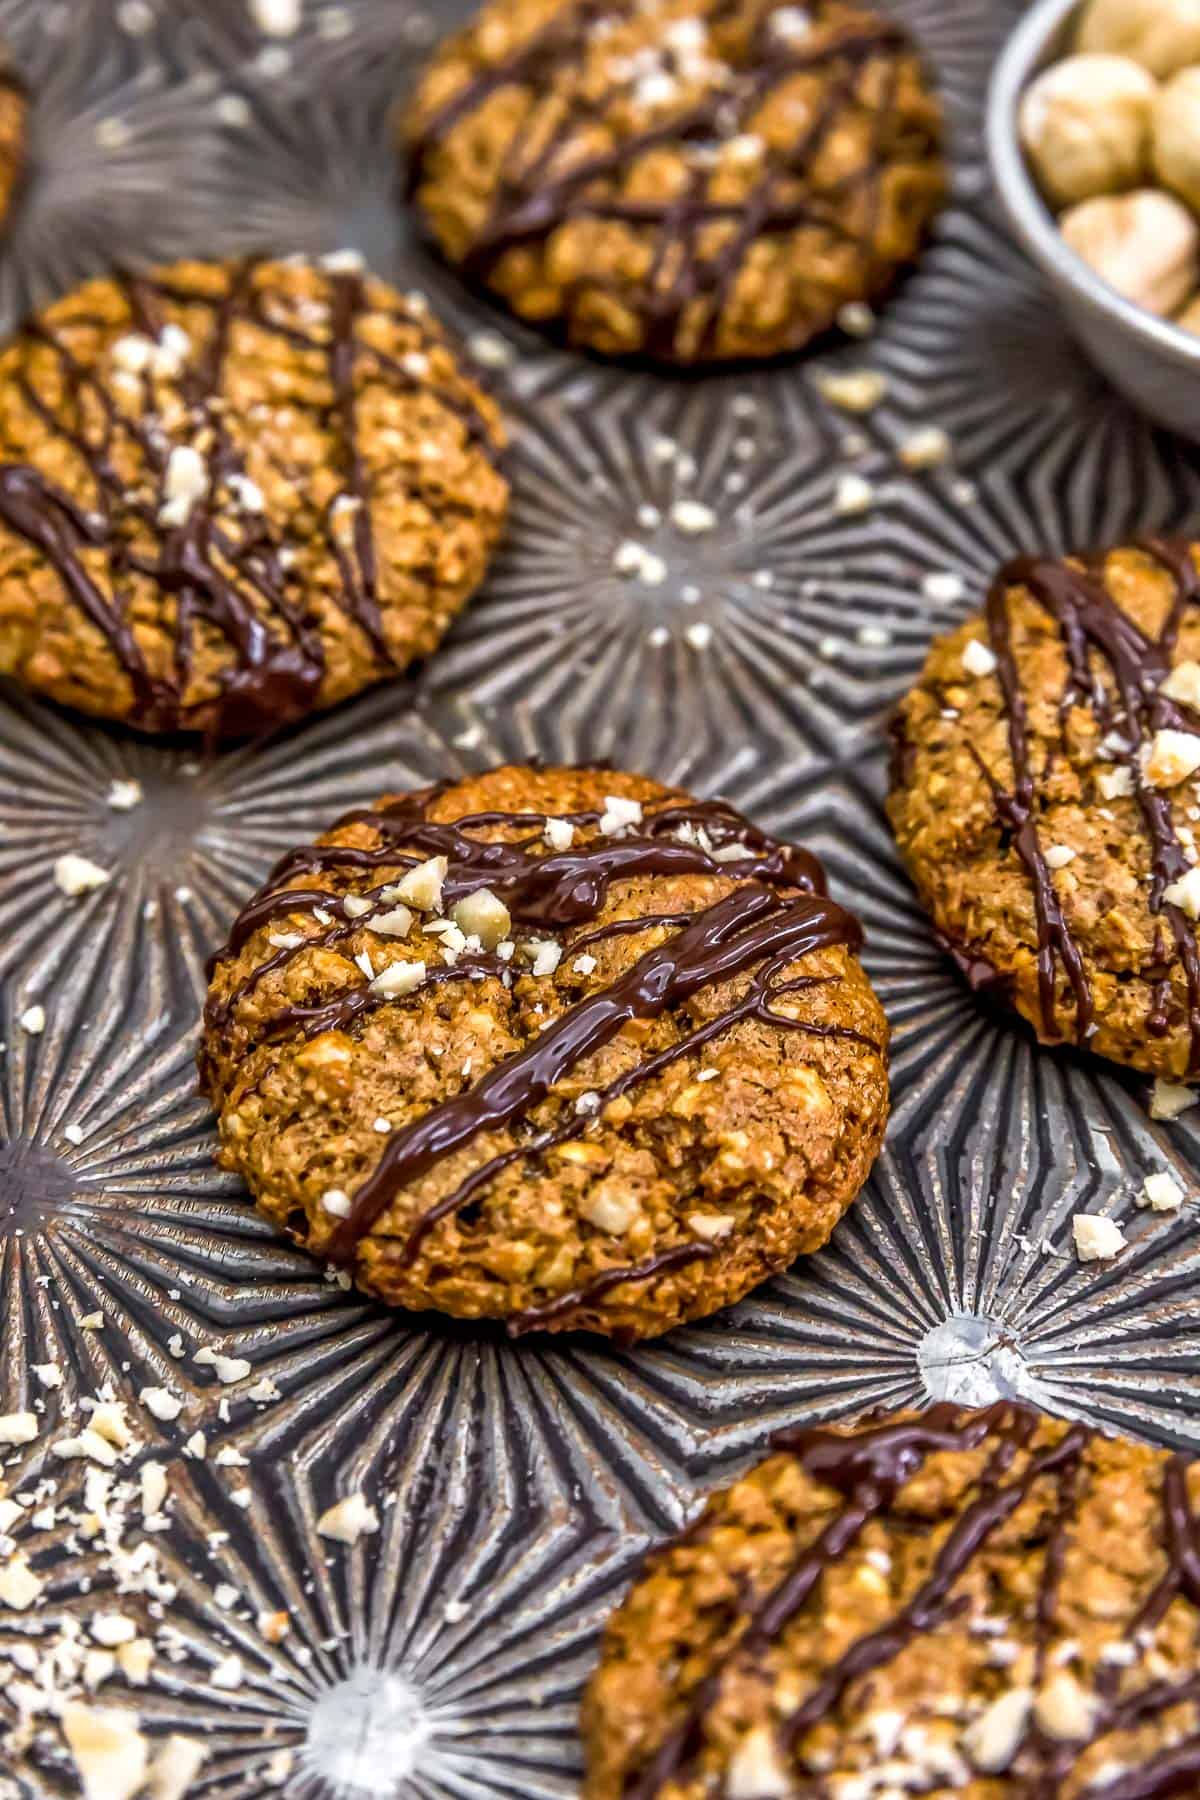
(583, 1404, 1200, 1800)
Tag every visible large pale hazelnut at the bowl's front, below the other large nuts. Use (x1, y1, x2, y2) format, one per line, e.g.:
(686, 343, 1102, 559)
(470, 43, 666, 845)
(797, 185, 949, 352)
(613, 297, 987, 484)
(1060, 187, 1200, 319)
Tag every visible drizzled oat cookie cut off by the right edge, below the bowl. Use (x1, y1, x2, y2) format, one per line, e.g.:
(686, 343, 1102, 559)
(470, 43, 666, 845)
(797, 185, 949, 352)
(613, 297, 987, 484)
(889, 538, 1200, 1080)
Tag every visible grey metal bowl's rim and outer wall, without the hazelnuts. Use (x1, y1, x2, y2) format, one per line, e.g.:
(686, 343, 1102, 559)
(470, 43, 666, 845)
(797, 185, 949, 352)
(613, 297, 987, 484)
(988, 0, 1200, 443)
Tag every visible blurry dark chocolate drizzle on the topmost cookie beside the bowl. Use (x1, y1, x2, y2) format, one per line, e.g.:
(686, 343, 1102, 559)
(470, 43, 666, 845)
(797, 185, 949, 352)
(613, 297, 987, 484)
(408, 0, 937, 360)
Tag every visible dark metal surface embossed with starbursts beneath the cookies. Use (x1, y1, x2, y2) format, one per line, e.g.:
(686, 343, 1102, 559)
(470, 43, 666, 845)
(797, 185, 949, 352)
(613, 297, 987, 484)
(0, 0, 1200, 1800)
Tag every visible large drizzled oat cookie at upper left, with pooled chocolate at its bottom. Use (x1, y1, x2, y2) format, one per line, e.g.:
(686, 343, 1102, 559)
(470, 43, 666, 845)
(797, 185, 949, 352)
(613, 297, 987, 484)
(0, 254, 507, 738)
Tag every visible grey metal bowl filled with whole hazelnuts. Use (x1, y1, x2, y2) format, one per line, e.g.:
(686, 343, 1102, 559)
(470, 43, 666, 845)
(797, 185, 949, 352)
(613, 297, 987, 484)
(988, 0, 1200, 441)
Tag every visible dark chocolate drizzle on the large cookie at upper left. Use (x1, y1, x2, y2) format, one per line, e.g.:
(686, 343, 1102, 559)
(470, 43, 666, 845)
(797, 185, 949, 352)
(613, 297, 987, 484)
(0, 261, 498, 736)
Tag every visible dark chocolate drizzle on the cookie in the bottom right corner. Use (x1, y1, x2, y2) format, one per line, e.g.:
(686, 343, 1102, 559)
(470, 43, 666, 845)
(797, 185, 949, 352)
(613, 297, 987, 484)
(622, 1400, 1200, 1800)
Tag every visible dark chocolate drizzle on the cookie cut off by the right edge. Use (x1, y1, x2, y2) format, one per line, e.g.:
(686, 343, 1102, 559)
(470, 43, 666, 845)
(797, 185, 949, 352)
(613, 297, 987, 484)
(981, 538, 1200, 1076)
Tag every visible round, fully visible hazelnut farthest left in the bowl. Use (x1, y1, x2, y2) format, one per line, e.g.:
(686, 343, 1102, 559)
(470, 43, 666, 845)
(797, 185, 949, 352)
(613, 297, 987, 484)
(1020, 56, 1159, 207)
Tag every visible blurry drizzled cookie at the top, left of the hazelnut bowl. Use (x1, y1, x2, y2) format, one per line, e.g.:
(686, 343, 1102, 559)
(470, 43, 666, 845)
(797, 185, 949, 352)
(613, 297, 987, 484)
(401, 0, 945, 364)
